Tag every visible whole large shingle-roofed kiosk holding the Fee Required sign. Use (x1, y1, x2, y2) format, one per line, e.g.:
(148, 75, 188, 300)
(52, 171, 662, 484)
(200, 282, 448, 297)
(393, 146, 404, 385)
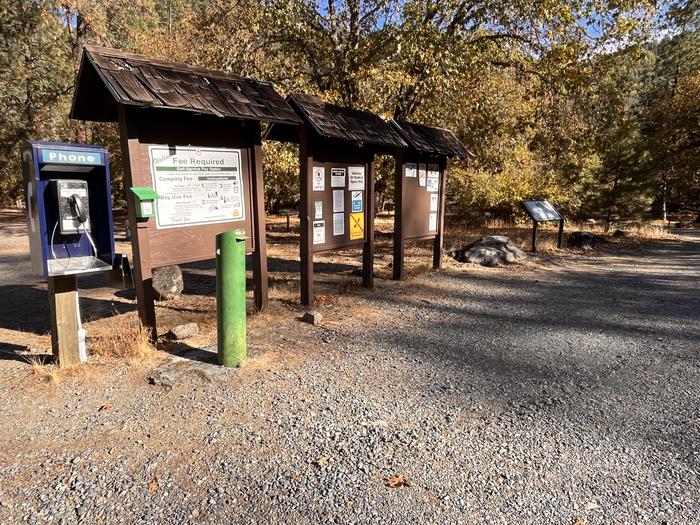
(70, 47, 301, 338)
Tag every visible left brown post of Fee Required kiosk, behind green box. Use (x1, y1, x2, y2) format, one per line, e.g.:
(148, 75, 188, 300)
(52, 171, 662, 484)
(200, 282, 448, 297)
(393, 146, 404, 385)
(119, 104, 158, 341)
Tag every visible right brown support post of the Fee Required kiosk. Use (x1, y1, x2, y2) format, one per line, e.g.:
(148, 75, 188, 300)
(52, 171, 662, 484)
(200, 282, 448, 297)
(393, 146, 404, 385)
(250, 122, 270, 312)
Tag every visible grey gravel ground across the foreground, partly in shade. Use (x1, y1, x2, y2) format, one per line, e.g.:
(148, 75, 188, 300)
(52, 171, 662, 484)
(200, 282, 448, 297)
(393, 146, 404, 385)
(0, 233, 700, 525)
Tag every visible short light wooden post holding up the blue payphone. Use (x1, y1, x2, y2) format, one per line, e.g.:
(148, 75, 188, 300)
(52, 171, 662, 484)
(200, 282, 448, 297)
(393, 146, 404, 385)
(48, 275, 80, 367)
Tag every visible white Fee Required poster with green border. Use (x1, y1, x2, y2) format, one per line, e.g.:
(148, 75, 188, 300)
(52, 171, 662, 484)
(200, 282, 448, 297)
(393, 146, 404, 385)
(148, 146, 245, 228)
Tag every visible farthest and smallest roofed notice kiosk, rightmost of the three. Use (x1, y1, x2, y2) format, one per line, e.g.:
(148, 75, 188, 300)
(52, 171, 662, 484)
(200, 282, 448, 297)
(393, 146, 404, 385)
(391, 121, 471, 280)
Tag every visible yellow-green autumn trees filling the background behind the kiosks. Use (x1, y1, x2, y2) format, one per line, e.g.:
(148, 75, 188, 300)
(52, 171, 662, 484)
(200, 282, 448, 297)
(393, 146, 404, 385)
(0, 0, 700, 218)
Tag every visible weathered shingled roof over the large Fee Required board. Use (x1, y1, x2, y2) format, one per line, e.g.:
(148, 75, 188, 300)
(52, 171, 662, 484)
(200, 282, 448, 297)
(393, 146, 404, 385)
(70, 46, 301, 125)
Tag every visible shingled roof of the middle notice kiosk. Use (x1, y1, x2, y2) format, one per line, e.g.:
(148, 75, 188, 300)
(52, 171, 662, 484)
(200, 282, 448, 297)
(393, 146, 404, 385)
(266, 94, 406, 148)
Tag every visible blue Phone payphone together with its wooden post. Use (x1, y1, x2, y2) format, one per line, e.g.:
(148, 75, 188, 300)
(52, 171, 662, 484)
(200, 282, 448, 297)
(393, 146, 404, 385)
(22, 141, 119, 366)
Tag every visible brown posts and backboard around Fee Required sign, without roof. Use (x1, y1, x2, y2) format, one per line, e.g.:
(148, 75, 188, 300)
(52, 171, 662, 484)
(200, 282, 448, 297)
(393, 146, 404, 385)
(118, 104, 268, 340)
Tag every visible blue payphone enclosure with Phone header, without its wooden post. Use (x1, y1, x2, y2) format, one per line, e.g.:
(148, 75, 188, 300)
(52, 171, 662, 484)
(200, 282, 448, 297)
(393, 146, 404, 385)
(22, 141, 115, 278)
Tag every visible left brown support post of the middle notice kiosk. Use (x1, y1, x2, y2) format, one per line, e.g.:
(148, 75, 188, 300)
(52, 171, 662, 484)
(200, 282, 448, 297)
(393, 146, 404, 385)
(299, 123, 314, 306)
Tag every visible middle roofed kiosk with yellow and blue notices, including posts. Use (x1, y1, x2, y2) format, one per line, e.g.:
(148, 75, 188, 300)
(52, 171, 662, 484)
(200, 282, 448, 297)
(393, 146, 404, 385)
(266, 94, 406, 306)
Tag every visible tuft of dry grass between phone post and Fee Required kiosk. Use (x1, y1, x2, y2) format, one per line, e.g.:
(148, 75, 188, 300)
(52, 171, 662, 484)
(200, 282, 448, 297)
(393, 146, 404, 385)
(89, 317, 161, 365)
